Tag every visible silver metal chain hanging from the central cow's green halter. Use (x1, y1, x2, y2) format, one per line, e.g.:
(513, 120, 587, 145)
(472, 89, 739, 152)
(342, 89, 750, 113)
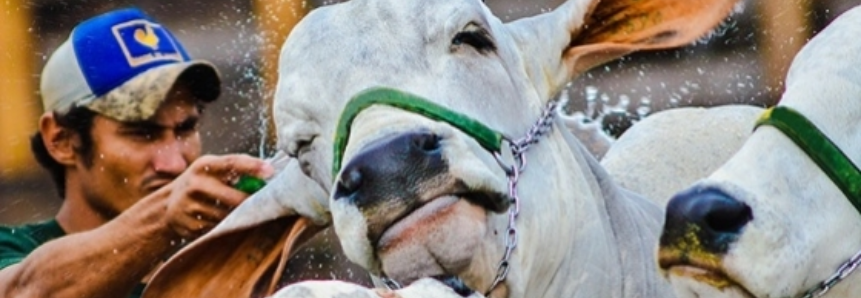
(484, 101, 558, 296)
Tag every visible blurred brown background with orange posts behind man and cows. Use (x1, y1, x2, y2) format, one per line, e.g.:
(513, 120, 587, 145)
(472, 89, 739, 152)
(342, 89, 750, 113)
(0, 0, 861, 224)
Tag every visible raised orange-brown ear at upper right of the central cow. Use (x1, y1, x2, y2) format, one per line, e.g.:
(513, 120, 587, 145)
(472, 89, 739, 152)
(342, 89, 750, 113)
(563, 0, 738, 74)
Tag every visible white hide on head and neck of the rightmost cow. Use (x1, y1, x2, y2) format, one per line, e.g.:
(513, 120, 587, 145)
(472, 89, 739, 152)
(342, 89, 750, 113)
(669, 4, 861, 298)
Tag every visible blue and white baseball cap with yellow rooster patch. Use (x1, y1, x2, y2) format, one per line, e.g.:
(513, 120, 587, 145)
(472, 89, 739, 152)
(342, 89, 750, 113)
(40, 8, 221, 122)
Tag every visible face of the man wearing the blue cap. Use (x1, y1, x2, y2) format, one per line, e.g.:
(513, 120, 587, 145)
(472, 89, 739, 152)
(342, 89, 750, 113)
(77, 84, 201, 218)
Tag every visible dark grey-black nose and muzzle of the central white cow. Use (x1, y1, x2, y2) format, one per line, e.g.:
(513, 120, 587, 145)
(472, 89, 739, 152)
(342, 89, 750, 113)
(333, 131, 511, 241)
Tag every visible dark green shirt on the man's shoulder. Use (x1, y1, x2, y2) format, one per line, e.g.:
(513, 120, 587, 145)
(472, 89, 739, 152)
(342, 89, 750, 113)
(0, 219, 144, 298)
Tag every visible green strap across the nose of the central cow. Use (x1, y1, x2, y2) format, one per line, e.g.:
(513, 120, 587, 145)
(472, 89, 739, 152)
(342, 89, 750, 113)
(332, 87, 504, 179)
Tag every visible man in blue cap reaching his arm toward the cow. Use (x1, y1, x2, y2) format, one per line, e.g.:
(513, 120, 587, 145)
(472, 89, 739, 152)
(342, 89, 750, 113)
(0, 9, 273, 298)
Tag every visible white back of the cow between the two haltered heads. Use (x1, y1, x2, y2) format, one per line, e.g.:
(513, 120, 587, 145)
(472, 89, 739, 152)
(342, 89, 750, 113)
(601, 105, 763, 206)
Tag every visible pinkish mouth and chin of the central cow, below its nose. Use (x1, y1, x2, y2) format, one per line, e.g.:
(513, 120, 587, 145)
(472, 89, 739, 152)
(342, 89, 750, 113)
(374, 191, 510, 297)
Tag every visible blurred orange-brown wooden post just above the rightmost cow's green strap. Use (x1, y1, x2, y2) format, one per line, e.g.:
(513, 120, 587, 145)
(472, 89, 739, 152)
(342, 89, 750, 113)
(755, 0, 811, 106)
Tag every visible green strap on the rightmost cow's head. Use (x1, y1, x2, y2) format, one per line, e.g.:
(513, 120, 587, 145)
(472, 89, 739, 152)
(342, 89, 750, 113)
(756, 106, 861, 212)
